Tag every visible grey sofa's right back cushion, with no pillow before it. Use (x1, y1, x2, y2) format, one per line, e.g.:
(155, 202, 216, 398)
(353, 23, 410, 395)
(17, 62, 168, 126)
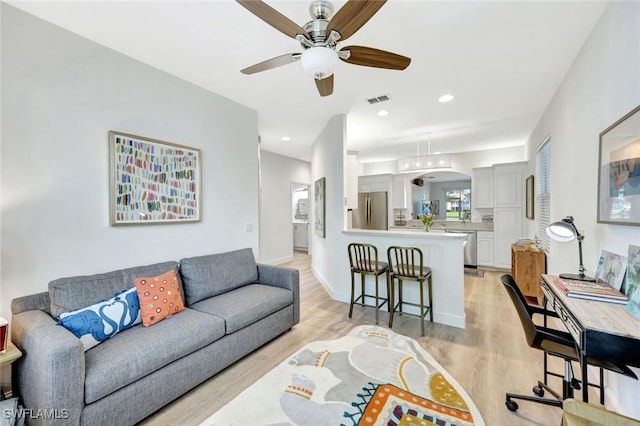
(180, 248, 258, 306)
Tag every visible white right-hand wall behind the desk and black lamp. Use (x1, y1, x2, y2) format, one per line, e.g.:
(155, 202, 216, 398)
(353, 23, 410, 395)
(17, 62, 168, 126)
(527, 2, 640, 418)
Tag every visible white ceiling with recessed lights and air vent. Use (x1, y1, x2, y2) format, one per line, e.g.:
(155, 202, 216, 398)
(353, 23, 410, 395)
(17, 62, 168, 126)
(8, 0, 606, 162)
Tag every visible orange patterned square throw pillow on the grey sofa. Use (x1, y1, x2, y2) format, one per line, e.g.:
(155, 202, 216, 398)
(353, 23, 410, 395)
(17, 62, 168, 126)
(135, 271, 184, 327)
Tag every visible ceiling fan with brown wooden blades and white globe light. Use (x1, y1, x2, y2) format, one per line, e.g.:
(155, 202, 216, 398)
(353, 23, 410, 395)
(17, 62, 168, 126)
(236, 0, 411, 96)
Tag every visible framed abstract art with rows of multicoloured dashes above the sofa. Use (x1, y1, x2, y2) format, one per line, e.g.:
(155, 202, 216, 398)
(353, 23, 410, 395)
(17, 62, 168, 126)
(109, 131, 201, 226)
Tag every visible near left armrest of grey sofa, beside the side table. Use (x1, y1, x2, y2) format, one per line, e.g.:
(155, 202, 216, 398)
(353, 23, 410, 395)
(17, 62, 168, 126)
(11, 310, 85, 425)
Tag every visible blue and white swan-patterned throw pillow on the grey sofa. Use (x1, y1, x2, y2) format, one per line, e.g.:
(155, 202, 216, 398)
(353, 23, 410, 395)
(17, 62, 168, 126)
(58, 287, 142, 351)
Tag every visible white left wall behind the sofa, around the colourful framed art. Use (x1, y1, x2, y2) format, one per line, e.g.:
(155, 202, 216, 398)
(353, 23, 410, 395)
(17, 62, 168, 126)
(0, 3, 259, 318)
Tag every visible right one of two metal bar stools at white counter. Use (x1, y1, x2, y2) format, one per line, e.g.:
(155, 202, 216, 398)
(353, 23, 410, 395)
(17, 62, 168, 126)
(387, 246, 433, 336)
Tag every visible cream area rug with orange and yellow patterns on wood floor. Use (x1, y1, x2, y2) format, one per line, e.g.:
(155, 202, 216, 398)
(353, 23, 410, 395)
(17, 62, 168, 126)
(202, 326, 485, 426)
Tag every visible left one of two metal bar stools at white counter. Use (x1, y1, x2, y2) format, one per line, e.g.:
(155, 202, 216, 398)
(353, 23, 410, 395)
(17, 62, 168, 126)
(347, 243, 389, 325)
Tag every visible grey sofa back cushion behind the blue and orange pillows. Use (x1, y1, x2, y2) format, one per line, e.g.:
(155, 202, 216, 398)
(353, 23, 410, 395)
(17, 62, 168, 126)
(49, 261, 178, 318)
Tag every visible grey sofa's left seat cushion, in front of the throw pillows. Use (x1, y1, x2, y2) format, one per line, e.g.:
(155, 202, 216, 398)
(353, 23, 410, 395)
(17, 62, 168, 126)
(85, 309, 225, 404)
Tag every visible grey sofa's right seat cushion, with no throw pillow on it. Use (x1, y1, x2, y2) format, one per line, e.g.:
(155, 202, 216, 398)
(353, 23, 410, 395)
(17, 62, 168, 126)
(190, 284, 293, 334)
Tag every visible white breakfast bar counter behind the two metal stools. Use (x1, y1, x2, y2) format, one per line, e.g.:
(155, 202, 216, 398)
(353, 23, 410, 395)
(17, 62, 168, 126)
(343, 229, 465, 328)
